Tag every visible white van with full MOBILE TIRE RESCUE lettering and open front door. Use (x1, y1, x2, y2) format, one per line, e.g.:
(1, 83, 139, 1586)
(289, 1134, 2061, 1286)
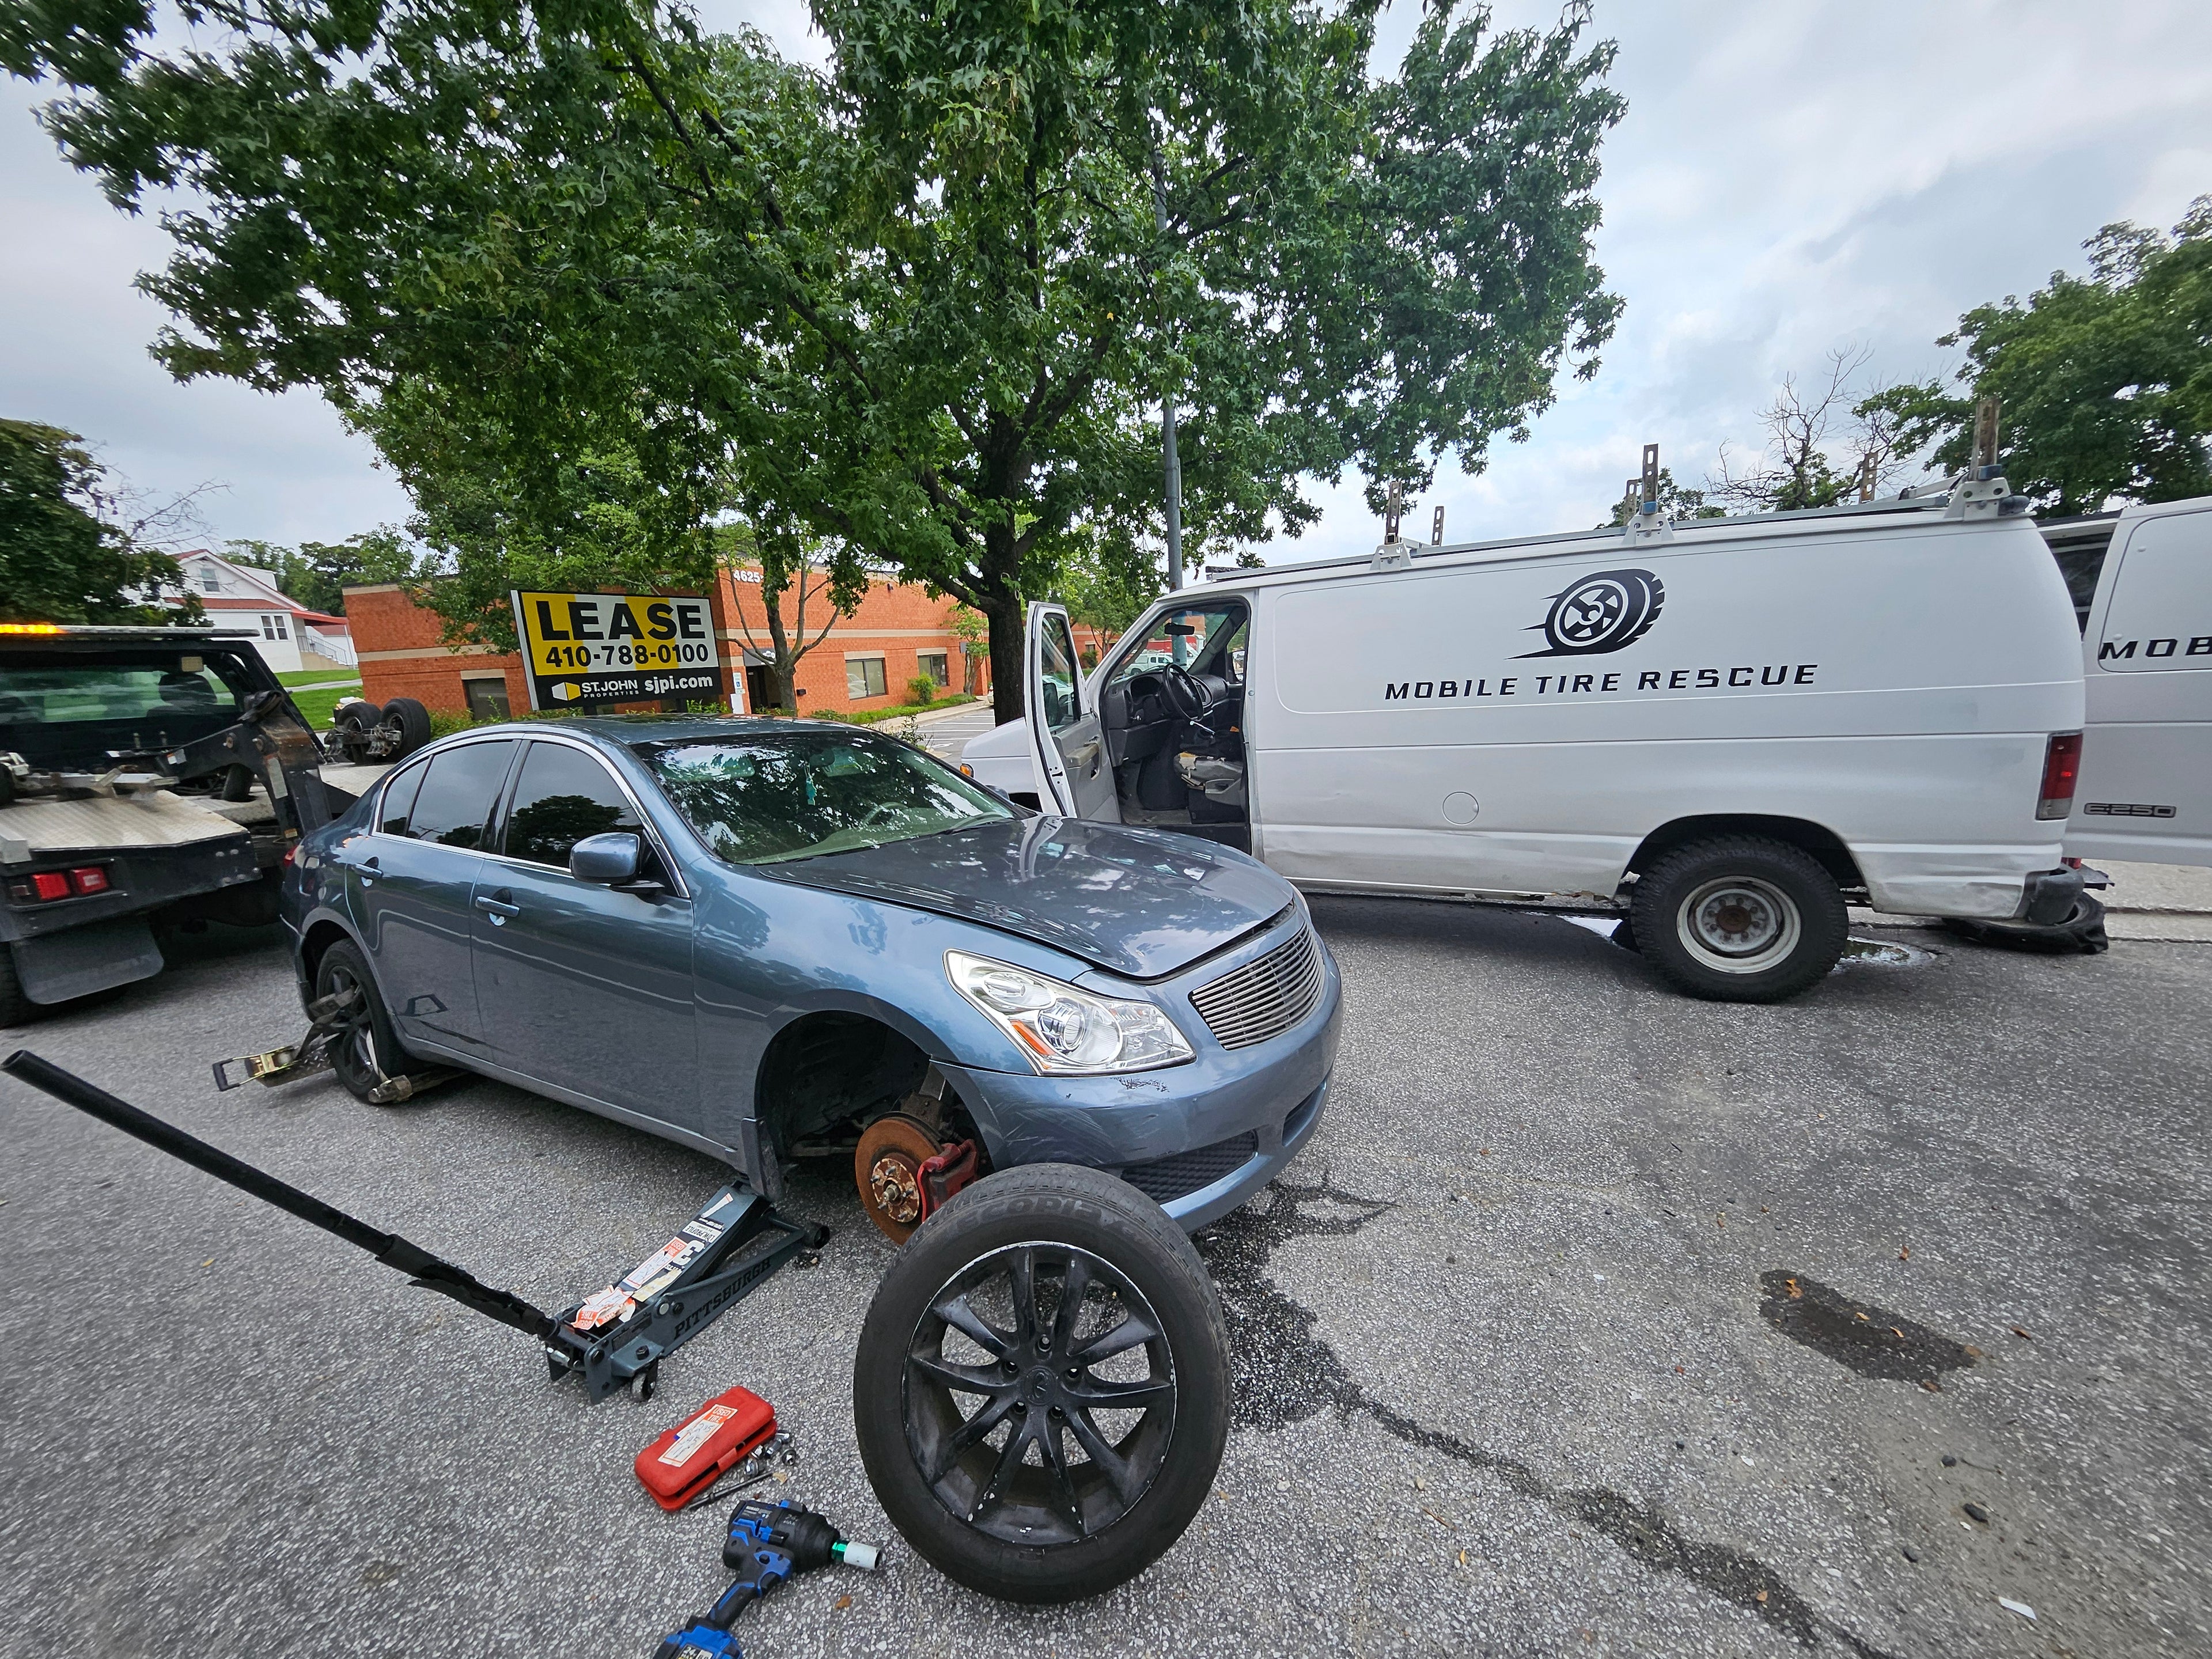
(962, 480, 2081, 1002)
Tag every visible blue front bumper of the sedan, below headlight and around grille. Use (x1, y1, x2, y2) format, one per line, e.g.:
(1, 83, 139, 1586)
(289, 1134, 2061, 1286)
(940, 916, 1343, 1232)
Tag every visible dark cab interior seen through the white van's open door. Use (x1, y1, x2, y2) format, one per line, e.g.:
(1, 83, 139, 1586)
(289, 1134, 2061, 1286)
(1099, 597, 1252, 851)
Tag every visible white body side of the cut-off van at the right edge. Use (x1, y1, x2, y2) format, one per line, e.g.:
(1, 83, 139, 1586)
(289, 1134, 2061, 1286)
(2066, 498, 2212, 865)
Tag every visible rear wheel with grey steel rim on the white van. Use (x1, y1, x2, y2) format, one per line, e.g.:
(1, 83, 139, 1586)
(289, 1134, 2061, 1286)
(1630, 836, 1847, 1002)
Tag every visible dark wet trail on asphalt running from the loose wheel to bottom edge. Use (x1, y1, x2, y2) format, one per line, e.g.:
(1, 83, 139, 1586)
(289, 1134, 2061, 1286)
(1195, 1177, 1891, 1659)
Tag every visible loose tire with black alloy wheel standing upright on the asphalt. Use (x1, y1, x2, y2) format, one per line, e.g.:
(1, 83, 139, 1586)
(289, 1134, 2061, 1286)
(851, 1164, 1230, 1601)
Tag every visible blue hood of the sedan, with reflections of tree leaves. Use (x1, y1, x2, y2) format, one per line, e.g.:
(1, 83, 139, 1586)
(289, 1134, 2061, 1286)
(754, 819, 1296, 980)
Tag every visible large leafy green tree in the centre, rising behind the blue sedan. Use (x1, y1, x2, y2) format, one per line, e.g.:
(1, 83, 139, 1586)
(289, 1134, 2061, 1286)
(0, 0, 1622, 717)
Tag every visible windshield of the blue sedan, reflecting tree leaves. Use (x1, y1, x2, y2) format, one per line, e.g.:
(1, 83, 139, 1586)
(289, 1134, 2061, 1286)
(639, 730, 1016, 865)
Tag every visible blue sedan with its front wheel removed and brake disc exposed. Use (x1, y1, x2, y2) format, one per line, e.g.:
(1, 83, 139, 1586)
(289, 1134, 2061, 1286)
(283, 719, 1338, 1238)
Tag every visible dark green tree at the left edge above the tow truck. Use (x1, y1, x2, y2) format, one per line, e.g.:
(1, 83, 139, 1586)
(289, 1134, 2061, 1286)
(0, 421, 201, 624)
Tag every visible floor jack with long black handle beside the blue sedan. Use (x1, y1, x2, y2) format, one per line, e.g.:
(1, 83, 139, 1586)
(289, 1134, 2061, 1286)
(0, 1048, 830, 1400)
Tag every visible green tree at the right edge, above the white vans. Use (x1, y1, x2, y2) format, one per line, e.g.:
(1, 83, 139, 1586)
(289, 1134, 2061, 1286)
(1860, 197, 2212, 518)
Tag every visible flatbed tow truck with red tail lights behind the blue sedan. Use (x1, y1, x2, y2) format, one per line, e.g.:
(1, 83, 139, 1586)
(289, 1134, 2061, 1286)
(0, 622, 429, 1024)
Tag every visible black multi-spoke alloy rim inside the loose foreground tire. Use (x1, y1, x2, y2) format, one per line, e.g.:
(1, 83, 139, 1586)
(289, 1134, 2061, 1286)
(903, 1243, 1175, 1548)
